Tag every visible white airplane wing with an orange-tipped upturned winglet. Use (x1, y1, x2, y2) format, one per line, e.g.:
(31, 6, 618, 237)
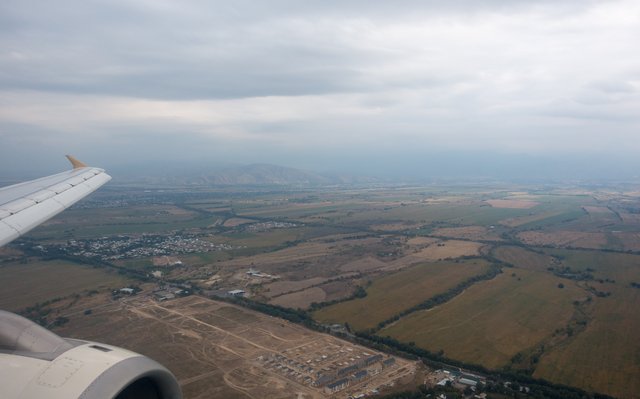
(0, 155, 111, 247)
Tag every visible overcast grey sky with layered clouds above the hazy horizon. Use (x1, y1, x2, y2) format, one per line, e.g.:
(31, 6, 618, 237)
(0, 0, 640, 177)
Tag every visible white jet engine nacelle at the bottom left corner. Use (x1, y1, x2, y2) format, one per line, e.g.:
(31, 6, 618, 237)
(0, 310, 182, 399)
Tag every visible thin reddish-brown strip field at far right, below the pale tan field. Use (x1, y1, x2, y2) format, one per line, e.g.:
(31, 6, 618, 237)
(518, 231, 607, 249)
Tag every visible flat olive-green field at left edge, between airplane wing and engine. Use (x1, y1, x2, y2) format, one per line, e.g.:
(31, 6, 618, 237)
(0, 259, 131, 311)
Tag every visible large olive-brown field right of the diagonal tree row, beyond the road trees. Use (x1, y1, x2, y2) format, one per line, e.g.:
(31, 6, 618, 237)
(378, 269, 585, 368)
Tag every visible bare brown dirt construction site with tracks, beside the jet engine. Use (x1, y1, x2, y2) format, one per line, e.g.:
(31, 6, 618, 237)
(57, 296, 415, 399)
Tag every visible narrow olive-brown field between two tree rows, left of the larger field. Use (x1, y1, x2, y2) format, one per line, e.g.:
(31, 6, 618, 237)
(313, 259, 489, 330)
